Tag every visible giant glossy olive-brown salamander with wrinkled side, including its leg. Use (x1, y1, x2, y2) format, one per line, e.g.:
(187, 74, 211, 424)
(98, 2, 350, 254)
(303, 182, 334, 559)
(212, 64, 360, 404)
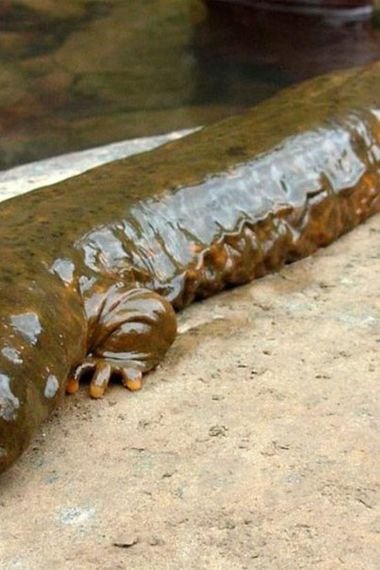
(0, 63, 380, 471)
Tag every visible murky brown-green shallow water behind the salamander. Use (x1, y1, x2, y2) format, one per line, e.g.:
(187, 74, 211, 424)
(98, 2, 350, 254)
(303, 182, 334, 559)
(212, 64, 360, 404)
(0, 0, 380, 168)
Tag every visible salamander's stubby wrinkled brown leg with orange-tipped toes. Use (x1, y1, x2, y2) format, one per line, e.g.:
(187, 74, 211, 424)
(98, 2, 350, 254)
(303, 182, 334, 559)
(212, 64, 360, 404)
(66, 286, 177, 398)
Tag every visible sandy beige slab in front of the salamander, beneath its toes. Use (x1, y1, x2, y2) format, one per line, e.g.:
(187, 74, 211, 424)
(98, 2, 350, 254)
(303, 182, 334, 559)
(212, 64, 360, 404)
(0, 134, 380, 570)
